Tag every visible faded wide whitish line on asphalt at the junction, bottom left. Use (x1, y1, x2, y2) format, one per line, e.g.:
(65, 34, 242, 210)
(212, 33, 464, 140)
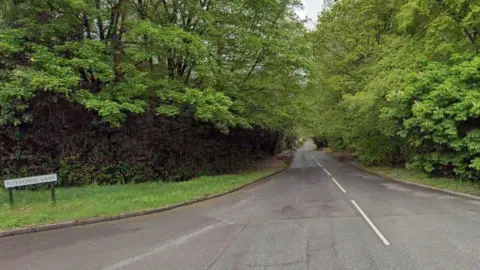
(103, 223, 220, 270)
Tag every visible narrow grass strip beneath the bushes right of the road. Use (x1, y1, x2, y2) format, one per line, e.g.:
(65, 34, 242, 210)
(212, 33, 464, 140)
(364, 166, 480, 196)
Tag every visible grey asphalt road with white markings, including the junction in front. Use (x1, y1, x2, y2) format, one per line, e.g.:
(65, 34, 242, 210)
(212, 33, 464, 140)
(0, 142, 480, 270)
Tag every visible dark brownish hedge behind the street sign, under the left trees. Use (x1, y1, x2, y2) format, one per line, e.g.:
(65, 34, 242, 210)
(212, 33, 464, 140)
(0, 95, 285, 186)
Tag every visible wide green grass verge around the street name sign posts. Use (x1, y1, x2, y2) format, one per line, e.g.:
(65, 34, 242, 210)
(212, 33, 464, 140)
(0, 169, 278, 230)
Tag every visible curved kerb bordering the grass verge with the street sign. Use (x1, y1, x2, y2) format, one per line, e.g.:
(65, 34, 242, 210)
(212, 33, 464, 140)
(0, 169, 288, 238)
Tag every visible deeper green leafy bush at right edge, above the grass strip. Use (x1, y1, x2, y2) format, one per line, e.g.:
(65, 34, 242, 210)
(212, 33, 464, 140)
(387, 55, 480, 179)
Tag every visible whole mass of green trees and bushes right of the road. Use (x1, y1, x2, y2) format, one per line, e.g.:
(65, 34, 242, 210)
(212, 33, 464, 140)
(311, 0, 480, 180)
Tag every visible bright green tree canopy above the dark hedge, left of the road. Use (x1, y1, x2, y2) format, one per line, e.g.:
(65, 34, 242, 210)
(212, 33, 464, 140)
(0, 0, 310, 130)
